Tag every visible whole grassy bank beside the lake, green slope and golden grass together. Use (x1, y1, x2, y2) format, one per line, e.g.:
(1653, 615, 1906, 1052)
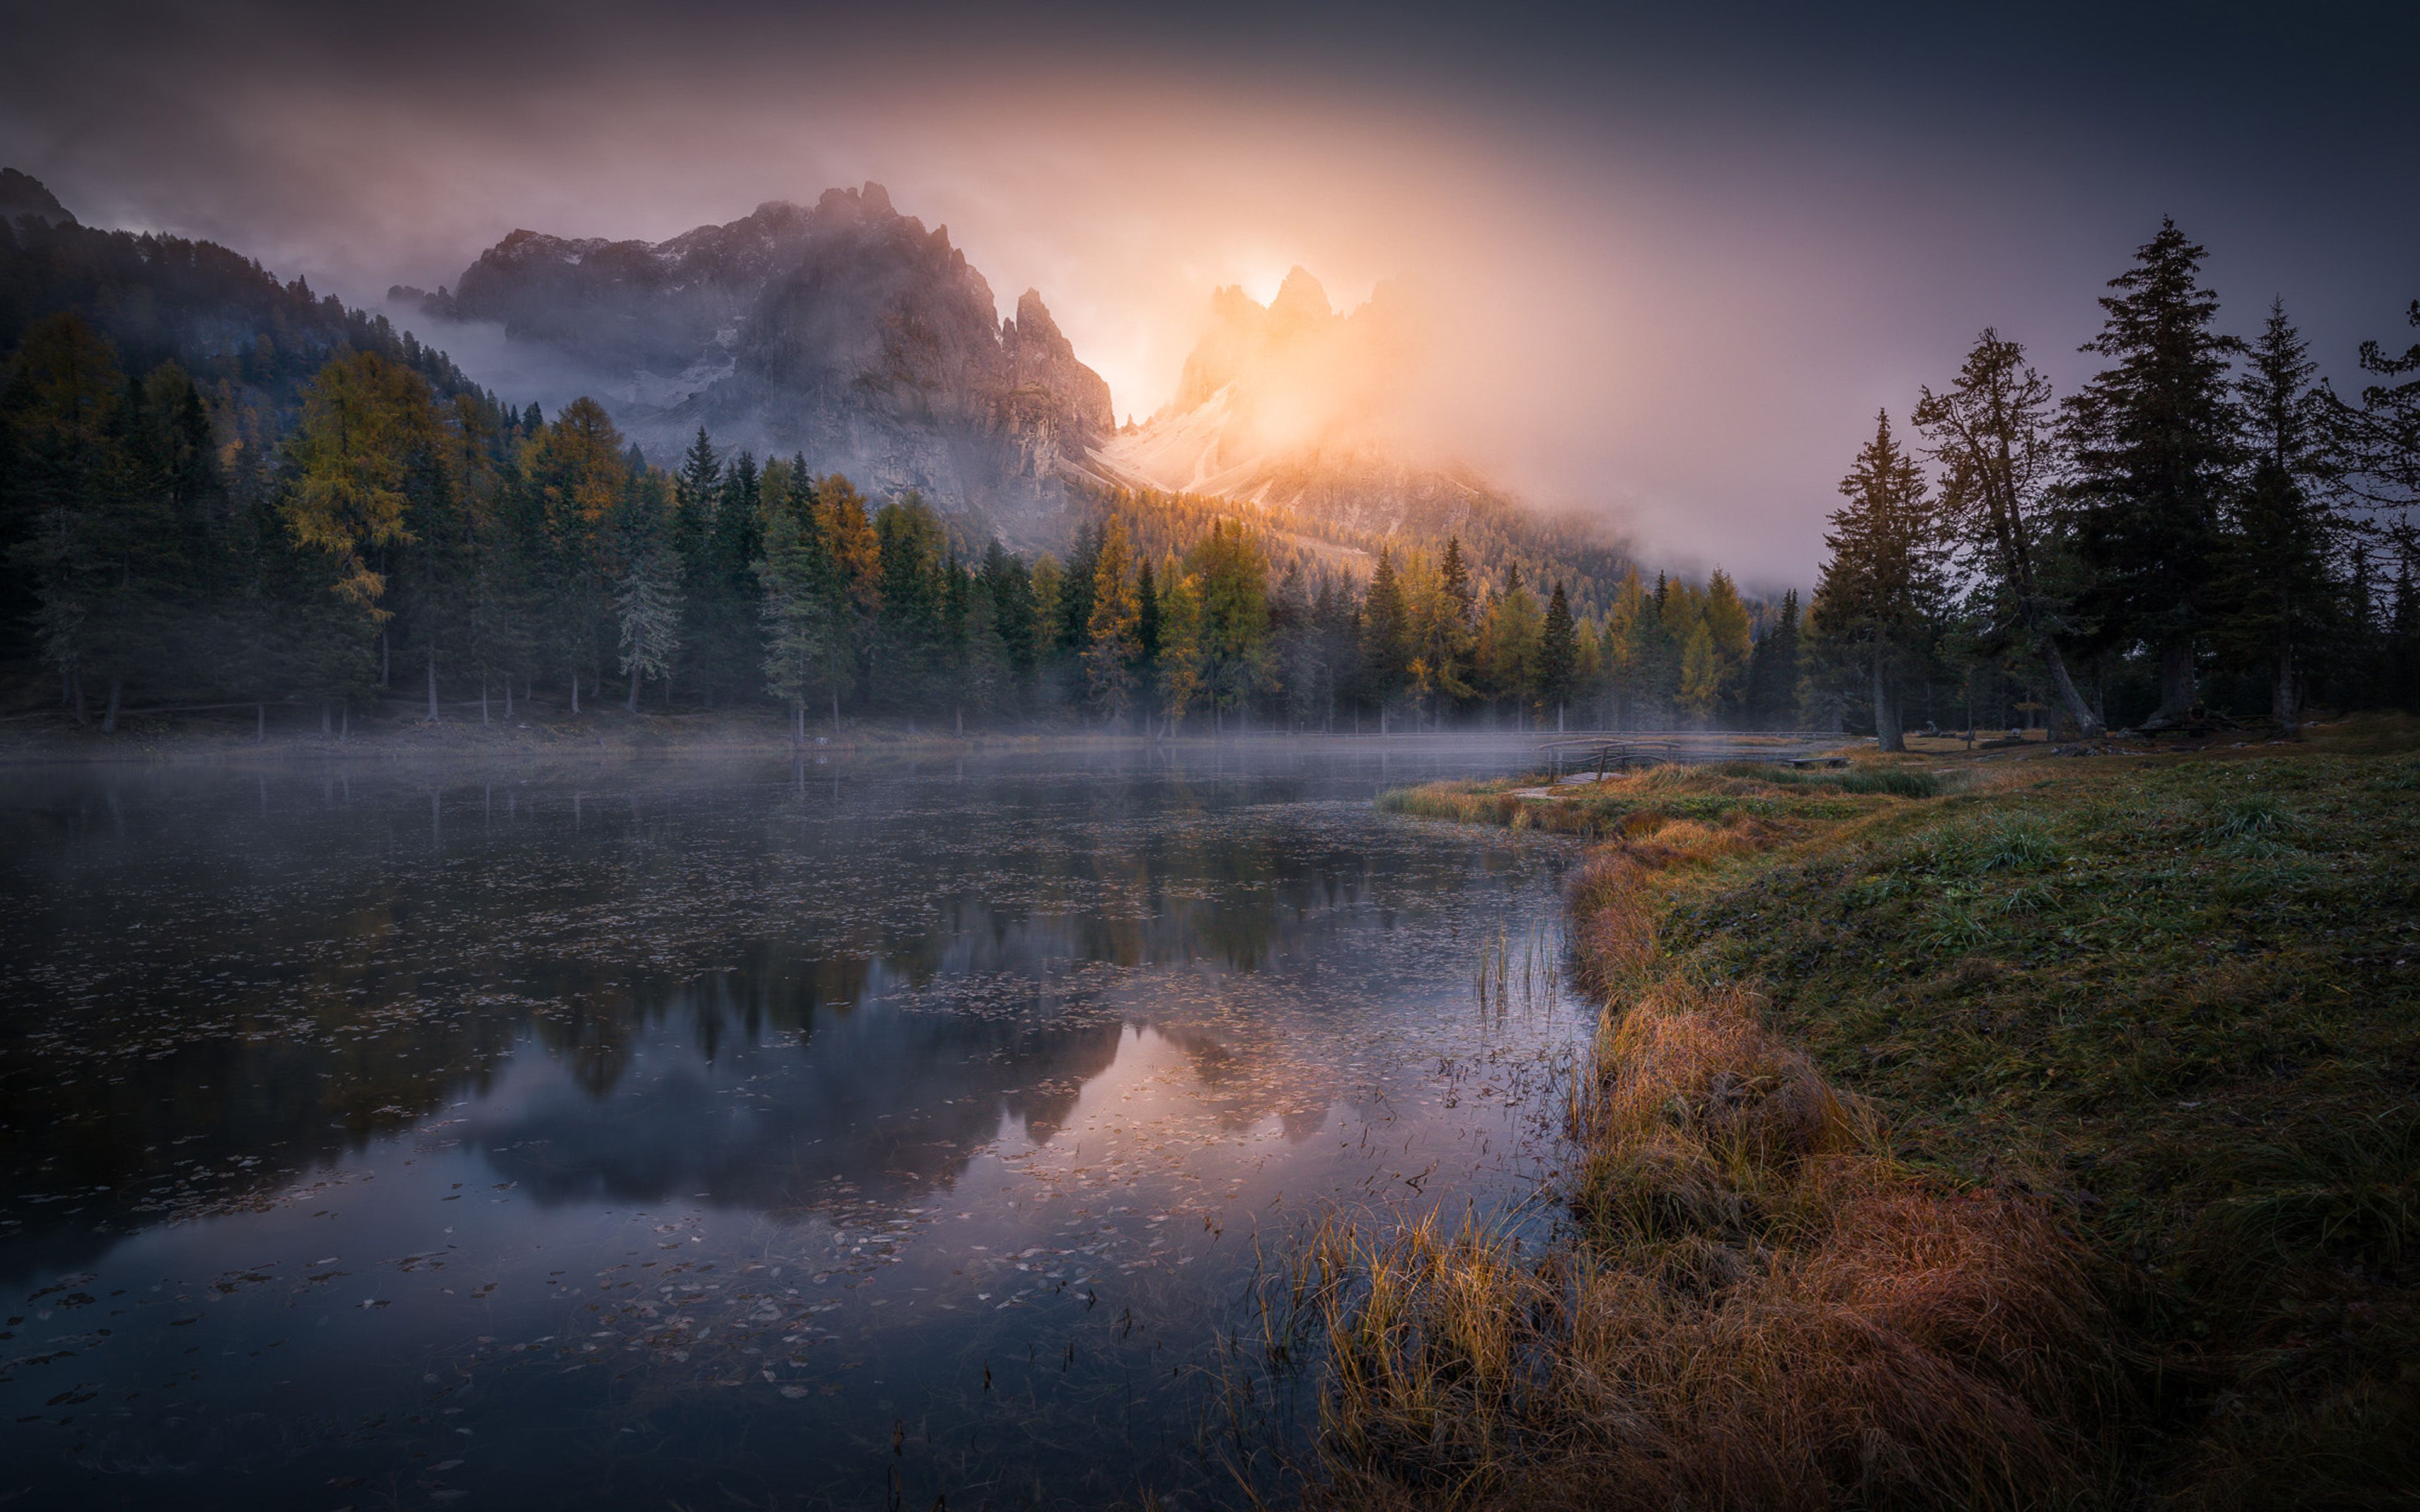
(1322, 723, 2420, 1507)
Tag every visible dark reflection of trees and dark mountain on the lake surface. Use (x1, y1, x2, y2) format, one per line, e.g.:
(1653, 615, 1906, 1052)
(0, 767, 1539, 1265)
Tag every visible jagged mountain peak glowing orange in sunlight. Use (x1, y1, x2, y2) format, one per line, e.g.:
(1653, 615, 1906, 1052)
(1089, 268, 1631, 607)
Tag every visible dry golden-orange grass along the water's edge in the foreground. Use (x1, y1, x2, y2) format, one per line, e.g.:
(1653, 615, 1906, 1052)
(1297, 774, 2108, 1509)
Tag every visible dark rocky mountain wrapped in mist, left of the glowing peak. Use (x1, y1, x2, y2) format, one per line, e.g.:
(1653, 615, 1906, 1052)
(389, 184, 1111, 539)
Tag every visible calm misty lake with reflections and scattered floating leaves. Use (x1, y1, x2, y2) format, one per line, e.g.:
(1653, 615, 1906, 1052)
(0, 748, 1587, 1509)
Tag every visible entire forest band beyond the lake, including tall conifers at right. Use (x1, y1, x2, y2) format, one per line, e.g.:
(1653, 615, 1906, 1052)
(0, 204, 2420, 748)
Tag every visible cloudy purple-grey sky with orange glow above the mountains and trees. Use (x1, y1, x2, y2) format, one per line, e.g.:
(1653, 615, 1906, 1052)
(0, 0, 2420, 588)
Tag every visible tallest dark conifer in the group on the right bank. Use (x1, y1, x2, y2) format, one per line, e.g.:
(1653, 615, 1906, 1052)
(2066, 220, 2244, 723)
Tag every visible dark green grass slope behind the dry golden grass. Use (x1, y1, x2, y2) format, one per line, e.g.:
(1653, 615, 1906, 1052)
(1394, 721, 2420, 1507)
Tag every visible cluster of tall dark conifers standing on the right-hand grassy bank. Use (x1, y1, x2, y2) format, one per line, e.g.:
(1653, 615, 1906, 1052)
(1803, 220, 2420, 750)
